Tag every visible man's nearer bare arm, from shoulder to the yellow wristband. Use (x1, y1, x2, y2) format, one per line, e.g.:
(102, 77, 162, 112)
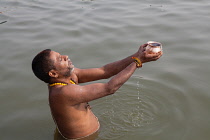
(62, 61, 137, 105)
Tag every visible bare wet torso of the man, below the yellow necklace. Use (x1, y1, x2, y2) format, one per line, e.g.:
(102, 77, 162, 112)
(49, 81, 99, 138)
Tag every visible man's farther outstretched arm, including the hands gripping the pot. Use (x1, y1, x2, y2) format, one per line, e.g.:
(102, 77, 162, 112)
(75, 44, 162, 83)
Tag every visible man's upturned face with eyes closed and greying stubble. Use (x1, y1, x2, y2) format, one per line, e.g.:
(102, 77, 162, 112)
(50, 51, 74, 77)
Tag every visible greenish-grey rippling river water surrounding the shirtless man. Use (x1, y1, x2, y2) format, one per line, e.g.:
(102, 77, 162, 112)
(0, 0, 210, 140)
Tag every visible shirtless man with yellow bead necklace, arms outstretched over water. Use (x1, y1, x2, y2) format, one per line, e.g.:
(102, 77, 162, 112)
(32, 44, 162, 139)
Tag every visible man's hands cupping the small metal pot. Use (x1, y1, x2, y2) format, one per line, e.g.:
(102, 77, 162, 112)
(138, 44, 163, 63)
